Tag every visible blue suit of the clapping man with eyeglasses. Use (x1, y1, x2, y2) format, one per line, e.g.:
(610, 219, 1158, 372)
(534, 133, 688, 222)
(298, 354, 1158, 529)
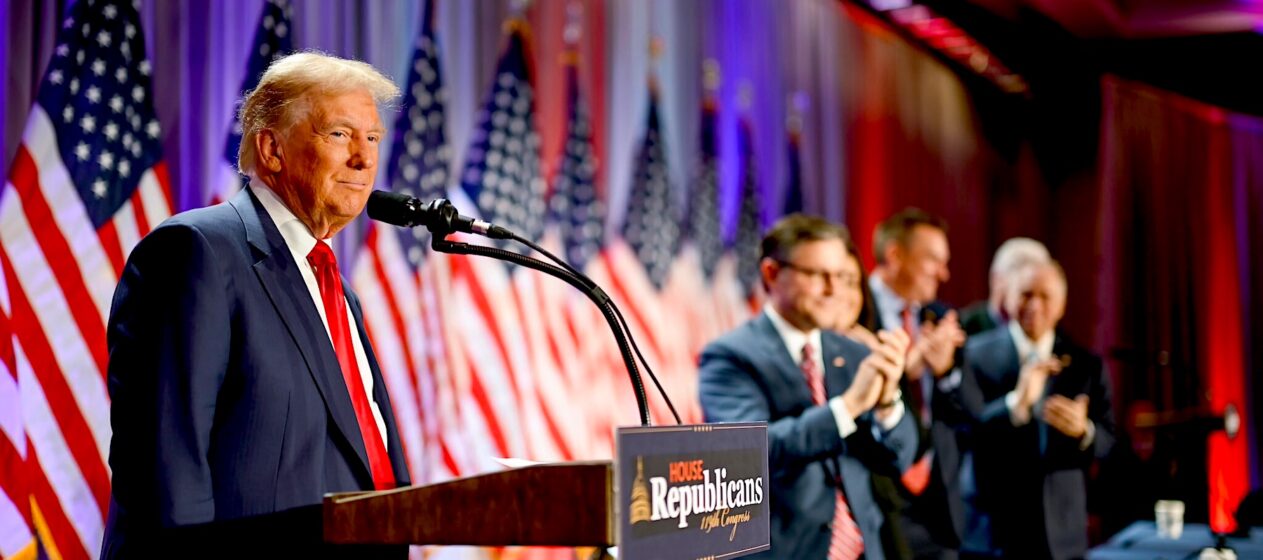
(700, 313, 917, 560)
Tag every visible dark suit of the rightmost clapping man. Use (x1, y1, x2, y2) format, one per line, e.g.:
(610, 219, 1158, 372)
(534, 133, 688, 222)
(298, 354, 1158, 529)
(961, 329, 1114, 559)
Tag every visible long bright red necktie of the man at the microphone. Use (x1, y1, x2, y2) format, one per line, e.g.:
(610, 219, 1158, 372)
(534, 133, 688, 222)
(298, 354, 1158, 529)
(307, 240, 395, 490)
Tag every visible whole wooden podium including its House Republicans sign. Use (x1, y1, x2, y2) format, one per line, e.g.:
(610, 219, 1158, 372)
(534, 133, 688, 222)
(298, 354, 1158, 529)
(322, 422, 770, 560)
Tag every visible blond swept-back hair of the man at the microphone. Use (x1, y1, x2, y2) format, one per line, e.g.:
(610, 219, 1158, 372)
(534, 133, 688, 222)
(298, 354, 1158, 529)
(237, 52, 399, 176)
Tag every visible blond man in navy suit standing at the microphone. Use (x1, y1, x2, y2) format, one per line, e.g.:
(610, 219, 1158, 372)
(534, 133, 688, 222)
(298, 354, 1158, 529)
(101, 53, 408, 559)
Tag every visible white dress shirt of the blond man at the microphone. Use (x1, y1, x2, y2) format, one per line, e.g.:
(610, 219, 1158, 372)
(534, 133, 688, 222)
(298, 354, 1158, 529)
(250, 181, 389, 449)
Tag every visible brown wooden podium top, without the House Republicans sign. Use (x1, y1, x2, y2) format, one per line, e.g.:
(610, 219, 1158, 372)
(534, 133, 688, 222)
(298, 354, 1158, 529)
(323, 461, 618, 547)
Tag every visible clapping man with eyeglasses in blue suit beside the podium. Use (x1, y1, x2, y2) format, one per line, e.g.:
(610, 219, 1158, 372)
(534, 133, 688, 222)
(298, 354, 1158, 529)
(700, 214, 917, 560)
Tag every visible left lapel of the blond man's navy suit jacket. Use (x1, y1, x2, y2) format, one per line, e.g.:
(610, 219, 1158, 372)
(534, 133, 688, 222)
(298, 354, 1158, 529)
(230, 188, 371, 479)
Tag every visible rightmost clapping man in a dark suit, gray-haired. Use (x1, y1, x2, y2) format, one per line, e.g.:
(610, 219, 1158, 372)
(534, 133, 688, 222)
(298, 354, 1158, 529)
(960, 260, 1114, 560)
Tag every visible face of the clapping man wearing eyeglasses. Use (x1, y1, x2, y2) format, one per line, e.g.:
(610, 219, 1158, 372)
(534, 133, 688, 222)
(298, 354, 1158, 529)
(763, 239, 859, 331)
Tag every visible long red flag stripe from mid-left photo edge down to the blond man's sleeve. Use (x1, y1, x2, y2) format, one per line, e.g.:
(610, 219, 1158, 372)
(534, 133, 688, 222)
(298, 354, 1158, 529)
(0, 252, 110, 518)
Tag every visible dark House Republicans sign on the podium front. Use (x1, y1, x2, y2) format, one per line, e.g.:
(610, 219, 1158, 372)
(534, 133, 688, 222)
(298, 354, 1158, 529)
(615, 422, 770, 560)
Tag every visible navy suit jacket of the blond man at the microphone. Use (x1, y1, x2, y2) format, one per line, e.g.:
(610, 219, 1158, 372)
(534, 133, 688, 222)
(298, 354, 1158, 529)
(102, 190, 408, 559)
